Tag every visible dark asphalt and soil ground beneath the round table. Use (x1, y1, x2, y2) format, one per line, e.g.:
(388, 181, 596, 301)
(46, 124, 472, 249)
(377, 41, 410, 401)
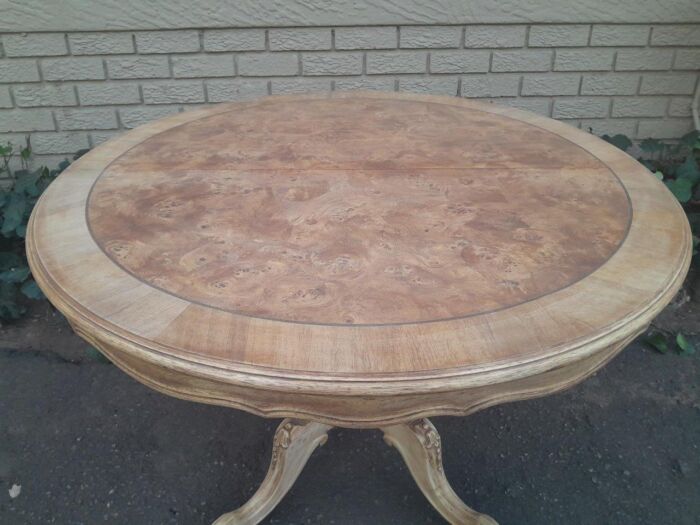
(0, 289, 700, 525)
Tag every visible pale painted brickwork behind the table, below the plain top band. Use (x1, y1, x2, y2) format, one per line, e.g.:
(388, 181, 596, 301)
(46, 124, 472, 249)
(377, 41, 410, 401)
(0, 24, 700, 162)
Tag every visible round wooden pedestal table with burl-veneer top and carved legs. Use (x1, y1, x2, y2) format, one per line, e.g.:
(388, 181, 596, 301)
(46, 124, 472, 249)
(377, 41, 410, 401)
(27, 93, 691, 525)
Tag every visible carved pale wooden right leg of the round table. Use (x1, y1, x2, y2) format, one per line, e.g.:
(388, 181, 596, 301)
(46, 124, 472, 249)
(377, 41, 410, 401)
(382, 419, 498, 525)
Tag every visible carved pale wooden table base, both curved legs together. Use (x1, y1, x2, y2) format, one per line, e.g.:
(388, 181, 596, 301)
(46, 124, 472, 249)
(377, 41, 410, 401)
(214, 419, 498, 525)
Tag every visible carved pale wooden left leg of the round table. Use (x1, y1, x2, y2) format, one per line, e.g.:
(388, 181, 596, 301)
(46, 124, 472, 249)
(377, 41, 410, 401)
(214, 419, 331, 525)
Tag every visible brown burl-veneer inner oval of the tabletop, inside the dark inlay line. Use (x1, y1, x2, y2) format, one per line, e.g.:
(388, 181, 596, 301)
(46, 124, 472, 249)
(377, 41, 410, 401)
(88, 99, 631, 324)
